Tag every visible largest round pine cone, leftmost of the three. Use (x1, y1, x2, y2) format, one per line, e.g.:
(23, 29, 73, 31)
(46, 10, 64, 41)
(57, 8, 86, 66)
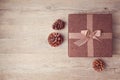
(48, 32, 63, 47)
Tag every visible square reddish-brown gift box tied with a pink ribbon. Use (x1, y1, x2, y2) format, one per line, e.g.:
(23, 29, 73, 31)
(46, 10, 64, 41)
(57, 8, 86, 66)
(68, 14, 112, 57)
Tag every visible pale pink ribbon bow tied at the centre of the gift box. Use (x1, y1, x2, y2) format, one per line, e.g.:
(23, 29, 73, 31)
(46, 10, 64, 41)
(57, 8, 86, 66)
(74, 30, 101, 46)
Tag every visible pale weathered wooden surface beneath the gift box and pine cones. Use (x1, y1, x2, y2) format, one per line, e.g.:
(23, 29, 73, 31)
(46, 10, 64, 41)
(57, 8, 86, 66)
(0, 0, 120, 80)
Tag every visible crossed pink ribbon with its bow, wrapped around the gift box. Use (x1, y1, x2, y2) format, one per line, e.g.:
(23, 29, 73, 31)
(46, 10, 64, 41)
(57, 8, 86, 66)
(69, 15, 112, 56)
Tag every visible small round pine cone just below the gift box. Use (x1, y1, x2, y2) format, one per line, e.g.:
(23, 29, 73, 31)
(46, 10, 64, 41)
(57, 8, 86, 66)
(93, 59, 105, 72)
